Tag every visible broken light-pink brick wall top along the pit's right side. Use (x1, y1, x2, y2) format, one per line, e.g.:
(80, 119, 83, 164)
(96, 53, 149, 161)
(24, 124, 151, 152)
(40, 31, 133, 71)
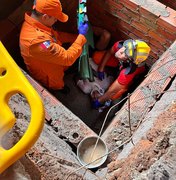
(102, 41, 176, 159)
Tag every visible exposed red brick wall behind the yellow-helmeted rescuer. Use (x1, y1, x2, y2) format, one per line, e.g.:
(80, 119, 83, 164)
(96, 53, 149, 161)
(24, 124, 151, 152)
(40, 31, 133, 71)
(85, 0, 176, 64)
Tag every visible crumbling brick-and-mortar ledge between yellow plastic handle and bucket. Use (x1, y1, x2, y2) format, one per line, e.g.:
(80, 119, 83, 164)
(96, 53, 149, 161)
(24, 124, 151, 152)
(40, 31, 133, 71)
(39, 90, 95, 144)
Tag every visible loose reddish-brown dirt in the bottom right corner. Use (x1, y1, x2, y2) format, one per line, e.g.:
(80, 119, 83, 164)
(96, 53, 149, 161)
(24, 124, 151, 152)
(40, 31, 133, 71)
(107, 104, 176, 180)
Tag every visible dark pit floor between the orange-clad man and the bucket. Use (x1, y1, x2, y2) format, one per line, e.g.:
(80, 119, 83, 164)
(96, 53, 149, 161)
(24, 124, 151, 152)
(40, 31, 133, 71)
(53, 63, 119, 134)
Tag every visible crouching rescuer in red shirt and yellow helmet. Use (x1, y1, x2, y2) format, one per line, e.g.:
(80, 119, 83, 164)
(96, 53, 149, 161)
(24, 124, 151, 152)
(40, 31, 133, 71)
(92, 39, 150, 109)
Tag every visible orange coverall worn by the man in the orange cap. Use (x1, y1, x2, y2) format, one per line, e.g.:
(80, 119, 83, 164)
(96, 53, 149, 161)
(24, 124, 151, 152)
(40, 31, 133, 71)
(20, 13, 86, 89)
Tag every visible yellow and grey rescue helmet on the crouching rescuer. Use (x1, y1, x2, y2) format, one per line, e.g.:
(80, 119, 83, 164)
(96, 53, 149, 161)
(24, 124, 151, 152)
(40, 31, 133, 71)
(123, 39, 150, 65)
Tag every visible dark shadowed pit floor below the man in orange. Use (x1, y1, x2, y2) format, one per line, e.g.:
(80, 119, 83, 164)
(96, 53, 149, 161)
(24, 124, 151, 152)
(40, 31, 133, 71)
(54, 69, 101, 133)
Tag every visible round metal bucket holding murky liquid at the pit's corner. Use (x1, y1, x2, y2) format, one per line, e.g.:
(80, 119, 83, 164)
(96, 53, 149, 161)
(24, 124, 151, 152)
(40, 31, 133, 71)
(77, 136, 108, 169)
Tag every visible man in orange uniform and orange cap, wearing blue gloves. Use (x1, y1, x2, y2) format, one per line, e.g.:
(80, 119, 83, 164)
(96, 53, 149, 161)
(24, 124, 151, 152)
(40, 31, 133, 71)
(20, 0, 88, 90)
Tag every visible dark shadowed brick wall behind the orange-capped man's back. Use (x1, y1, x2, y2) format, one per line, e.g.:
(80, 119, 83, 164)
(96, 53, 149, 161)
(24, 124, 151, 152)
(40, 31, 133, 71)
(0, 0, 33, 69)
